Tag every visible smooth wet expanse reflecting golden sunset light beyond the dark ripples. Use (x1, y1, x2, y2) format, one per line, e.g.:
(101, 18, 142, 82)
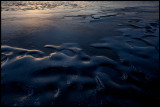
(1, 1, 158, 54)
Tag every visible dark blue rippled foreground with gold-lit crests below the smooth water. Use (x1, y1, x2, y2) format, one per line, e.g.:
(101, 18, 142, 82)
(1, 38, 159, 106)
